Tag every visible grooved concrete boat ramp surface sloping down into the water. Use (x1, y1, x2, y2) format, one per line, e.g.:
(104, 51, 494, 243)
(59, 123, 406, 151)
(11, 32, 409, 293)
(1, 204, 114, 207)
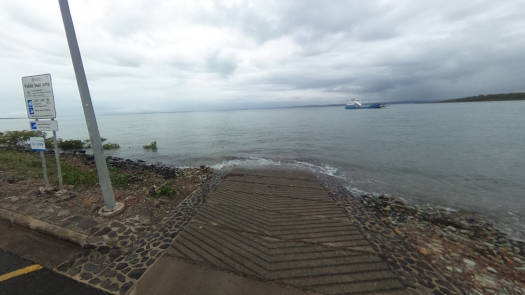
(168, 170, 405, 294)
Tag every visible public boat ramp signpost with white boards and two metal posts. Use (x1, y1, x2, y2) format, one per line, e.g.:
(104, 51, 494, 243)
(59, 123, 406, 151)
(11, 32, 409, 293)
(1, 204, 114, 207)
(22, 74, 63, 191)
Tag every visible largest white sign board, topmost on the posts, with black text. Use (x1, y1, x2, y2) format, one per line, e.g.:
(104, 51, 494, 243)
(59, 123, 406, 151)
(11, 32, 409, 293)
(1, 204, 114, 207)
(22, 74, 56, 119)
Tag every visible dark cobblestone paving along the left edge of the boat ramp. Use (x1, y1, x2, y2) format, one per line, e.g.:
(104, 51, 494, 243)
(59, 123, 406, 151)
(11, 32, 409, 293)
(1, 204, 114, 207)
(56, 175, 220, 294)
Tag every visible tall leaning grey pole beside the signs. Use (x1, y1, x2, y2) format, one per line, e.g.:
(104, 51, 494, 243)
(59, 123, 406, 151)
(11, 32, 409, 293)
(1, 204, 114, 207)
(58, 0, 115, 211)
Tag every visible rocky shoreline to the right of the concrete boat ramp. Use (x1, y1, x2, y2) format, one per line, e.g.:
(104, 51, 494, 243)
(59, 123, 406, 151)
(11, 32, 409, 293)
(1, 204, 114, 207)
(319, 175, 525, 295)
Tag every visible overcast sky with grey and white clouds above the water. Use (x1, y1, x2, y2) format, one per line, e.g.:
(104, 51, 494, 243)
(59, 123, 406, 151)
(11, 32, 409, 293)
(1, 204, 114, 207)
(0, 0, 525, 117)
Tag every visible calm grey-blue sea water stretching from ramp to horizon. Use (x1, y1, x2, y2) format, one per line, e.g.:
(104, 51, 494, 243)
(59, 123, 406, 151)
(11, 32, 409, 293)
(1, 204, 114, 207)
(0, 101, 525, 237)
